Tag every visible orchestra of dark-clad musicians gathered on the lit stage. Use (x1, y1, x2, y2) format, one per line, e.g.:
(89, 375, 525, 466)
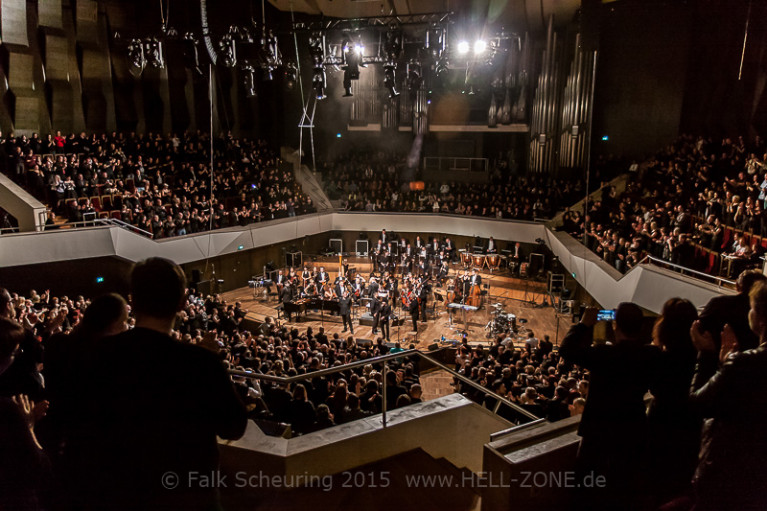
(264, 230, 510, 334)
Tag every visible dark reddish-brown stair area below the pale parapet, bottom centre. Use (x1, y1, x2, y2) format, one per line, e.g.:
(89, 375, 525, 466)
(221, 449, 481, 511)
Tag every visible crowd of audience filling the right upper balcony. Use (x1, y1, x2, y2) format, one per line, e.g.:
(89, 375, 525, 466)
(563, 136, 767, 275)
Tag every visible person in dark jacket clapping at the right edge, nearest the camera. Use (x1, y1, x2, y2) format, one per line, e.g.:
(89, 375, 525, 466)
(690, 282, 767, 511)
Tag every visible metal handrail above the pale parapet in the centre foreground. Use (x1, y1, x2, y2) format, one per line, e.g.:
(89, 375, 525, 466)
(229, 349, 545, 428)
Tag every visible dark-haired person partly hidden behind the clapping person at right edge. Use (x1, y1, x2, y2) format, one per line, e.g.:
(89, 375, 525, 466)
(696, 270, 767, 351)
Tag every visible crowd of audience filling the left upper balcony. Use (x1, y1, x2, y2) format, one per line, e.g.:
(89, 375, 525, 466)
(0, 132, 314, 238)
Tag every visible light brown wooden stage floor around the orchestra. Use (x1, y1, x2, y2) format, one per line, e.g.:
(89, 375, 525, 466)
(221, 258, 571, 350)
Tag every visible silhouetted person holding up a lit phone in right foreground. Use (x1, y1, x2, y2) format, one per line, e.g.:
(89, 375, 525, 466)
(559, 302, 658, 509)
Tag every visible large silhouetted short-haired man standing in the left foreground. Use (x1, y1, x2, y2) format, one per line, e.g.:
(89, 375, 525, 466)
(83, 258, 247, 510)
